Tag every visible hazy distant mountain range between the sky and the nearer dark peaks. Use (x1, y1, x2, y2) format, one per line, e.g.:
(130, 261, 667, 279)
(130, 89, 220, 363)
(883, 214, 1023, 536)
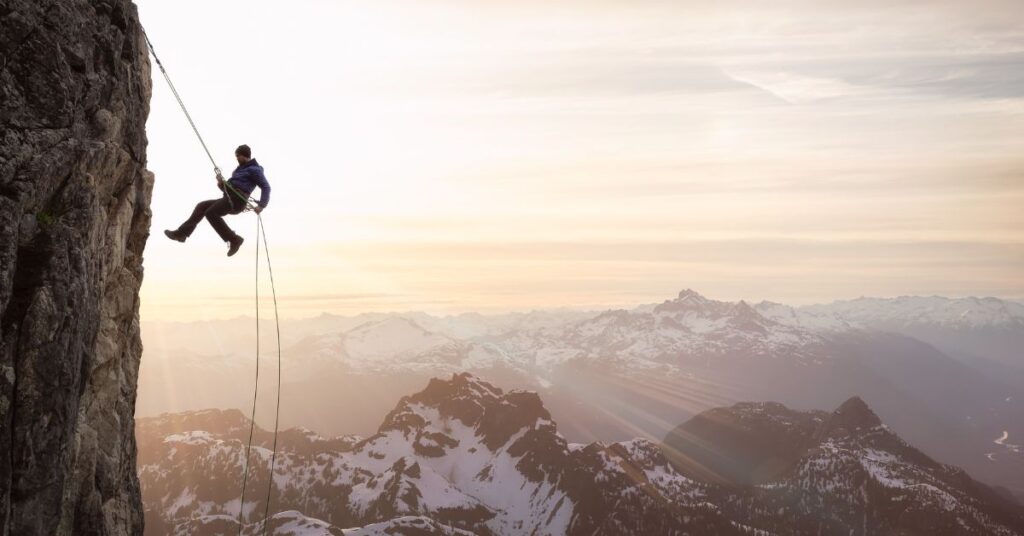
(138, 290, 1024, 502)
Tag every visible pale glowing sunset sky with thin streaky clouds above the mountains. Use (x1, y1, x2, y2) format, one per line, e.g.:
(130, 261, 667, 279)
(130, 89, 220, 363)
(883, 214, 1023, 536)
(137, 0, 1024, 320)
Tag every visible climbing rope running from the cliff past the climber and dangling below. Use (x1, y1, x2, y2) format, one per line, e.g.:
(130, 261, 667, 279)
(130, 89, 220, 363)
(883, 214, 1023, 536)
(142, 30, 282, 536)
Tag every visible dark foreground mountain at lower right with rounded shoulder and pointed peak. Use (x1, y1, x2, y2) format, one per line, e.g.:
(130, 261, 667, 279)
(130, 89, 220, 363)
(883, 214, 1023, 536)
(665, 398, 1024, 535)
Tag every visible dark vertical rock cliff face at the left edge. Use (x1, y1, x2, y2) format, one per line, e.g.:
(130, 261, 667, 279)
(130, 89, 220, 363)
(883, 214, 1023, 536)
(0, 0, 153, 535)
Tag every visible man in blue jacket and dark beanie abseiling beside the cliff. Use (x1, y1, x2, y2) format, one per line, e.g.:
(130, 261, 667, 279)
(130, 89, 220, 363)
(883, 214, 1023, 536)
(164, 146, 270, 256)
